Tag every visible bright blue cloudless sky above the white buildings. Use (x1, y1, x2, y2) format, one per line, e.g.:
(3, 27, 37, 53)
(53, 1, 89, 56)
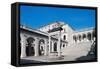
(20, 5, 95, 30)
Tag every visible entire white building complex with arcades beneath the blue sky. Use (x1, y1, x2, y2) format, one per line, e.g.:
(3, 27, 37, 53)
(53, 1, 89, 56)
(20, 22, 95, 58)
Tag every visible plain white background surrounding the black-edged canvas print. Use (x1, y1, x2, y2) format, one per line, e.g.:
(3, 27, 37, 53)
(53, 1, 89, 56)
(0, 0, 100, 69)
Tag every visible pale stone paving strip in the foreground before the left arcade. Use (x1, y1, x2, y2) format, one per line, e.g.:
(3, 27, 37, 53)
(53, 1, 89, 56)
(23, 56, 76, 62)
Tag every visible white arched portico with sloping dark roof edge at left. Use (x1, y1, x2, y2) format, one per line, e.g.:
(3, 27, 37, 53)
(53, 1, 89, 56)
(20, 25, 66, 58)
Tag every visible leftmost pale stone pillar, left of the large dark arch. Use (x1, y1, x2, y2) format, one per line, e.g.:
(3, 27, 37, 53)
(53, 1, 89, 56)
(20, 34, 26, 57)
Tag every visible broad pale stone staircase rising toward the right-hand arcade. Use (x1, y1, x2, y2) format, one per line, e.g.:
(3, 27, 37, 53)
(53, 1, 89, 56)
(62, 42, 92, 58)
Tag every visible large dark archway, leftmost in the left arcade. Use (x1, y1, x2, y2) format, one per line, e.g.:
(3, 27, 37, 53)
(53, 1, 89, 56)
(26, 37, 35, 56)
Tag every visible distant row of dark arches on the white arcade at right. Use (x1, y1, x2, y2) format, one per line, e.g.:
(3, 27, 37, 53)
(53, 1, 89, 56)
(73, 30, 95, 43)
